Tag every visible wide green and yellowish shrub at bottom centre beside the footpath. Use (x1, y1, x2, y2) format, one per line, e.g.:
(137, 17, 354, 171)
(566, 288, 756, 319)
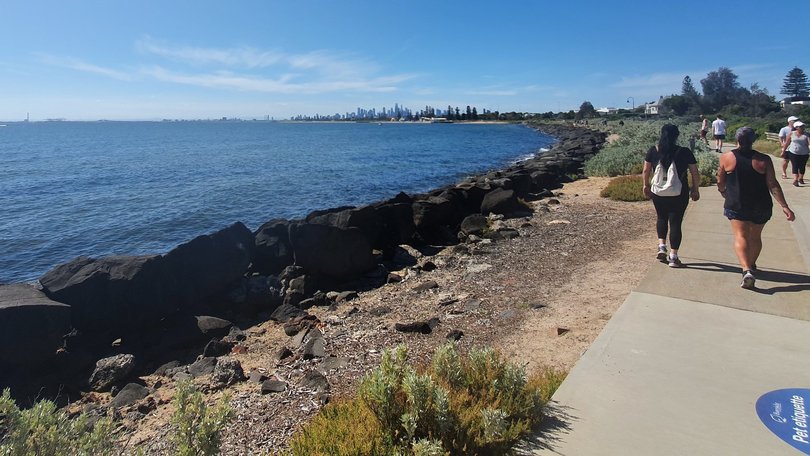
(290, 343, 564, 455)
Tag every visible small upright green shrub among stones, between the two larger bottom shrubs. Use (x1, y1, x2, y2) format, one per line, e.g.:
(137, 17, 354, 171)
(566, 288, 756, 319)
(171, 381, 232, 456)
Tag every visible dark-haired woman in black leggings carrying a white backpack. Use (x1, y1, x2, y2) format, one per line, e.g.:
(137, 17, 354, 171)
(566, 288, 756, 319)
(642, 124, 700, 268)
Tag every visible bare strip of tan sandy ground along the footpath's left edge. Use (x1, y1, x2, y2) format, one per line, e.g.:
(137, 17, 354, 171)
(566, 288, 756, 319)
(499, 178, 661, 371)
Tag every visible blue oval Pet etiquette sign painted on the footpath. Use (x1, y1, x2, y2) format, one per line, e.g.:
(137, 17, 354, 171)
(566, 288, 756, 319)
(757, 388, 810, 454)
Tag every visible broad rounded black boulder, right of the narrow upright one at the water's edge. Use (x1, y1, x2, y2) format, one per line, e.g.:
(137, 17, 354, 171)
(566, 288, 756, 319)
(290, 223, 377, 281)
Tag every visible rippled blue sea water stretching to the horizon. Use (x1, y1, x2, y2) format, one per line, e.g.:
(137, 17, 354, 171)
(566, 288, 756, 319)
(0, 122, 553, 283)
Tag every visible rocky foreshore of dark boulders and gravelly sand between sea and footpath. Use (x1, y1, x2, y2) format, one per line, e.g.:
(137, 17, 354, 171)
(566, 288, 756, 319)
(0, 125, 649, 453)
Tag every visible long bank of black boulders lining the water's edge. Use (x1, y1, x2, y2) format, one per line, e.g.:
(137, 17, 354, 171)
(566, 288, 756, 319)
(0, 125, 605, 402)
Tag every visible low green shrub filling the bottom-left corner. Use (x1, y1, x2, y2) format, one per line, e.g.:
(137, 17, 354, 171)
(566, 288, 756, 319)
(0, 389, 116, 456)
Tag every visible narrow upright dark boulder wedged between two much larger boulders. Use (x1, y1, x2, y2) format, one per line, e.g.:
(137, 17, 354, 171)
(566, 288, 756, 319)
(251, 219, 293, 275)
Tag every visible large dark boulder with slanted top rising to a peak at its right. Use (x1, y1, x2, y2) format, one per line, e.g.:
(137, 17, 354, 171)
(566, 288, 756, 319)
(164, 222, 254, 308)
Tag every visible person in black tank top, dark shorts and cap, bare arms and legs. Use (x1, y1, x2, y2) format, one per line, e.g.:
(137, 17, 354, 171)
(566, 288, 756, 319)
(717, 127, 796, 290)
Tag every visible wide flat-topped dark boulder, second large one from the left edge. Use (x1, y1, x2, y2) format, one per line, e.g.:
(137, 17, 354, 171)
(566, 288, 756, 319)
(39, 255, 169, 333)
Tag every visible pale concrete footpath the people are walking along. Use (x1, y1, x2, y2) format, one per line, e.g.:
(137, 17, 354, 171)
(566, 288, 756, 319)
(528, 155, 810, 456)
